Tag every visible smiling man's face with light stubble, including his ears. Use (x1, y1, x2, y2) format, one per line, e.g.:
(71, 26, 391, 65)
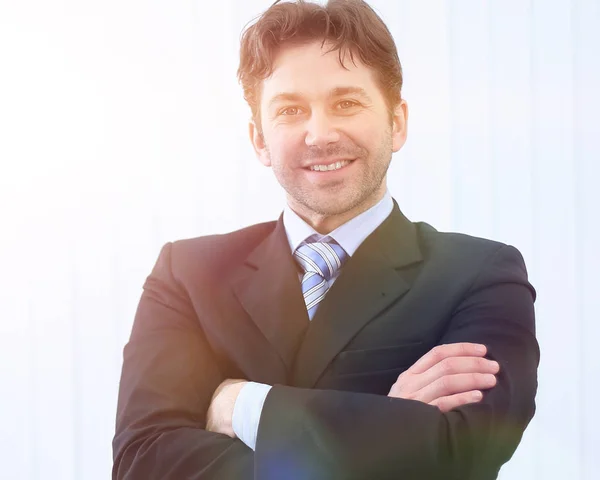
(250, 42, 407, 224)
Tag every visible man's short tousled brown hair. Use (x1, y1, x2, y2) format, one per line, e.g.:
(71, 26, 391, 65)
(237, 0, 402, 132)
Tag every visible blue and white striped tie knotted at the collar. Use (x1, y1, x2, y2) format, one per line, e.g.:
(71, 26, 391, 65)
(294, 235, 348, 320)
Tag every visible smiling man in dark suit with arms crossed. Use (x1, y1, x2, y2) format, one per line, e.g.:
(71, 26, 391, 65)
(113, 0, 539, 480)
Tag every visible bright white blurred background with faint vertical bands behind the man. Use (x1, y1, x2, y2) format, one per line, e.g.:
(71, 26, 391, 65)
(0, 0, 600, 480)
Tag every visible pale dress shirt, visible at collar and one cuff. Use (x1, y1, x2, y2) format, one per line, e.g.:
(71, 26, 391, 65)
(232, 191, 394, 450)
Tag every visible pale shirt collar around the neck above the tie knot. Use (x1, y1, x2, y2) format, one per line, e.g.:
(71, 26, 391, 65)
(283, 190, 394, 256)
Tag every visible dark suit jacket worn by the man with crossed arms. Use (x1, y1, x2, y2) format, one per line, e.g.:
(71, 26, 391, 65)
(113, 205, 539, 480)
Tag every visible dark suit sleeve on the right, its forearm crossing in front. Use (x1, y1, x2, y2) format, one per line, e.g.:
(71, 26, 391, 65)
(255, 246, 539, 480)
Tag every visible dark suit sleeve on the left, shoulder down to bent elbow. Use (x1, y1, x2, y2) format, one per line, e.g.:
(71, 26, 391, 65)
(112, 244, 254, 480)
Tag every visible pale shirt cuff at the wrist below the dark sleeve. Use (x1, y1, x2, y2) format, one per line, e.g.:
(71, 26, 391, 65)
(231, 382, 272, 450)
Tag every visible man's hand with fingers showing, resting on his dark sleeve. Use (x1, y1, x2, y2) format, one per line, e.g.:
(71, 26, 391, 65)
(388, 343, 500, 412)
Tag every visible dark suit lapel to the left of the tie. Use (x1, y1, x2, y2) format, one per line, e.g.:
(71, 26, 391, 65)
(232, 217, 308, 371)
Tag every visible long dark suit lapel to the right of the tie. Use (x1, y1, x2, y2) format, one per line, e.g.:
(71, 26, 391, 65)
(294, 202, 422, 388)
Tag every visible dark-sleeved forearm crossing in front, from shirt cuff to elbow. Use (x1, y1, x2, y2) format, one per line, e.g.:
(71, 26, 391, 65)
(254, 385, 533, 480)
